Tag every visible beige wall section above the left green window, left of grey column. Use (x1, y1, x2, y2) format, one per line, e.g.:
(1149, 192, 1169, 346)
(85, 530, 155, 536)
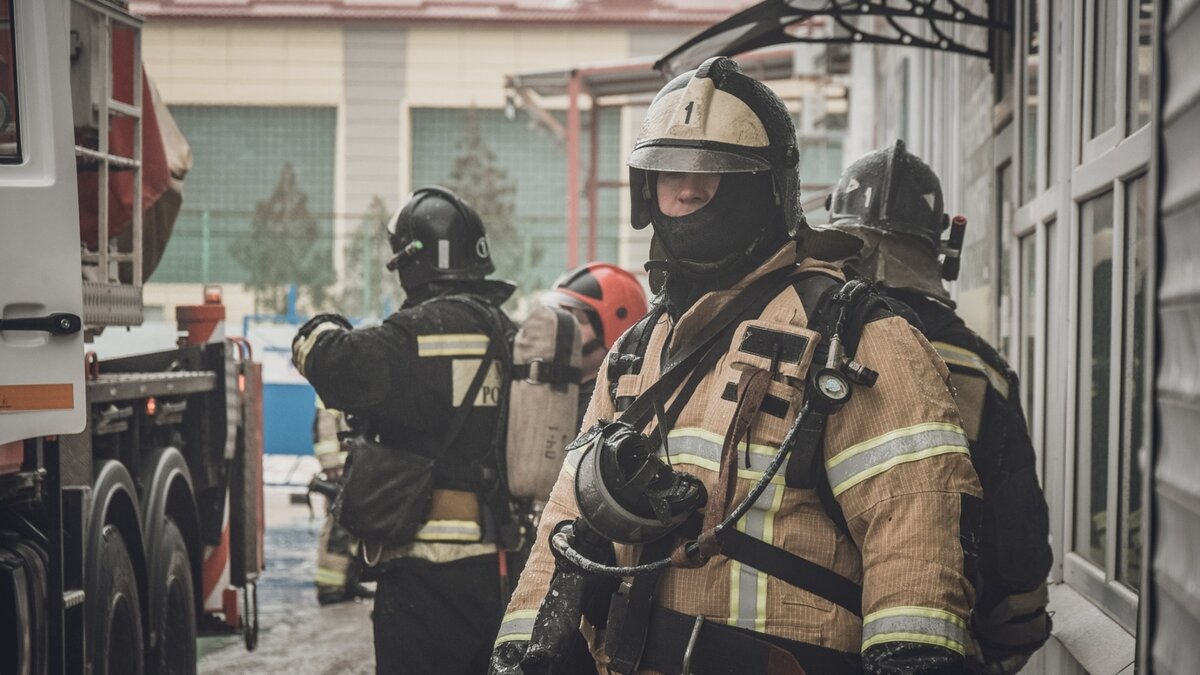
(142, 20, 343, 106)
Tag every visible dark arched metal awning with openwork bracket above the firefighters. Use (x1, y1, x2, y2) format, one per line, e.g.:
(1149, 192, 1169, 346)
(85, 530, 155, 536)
(654, 0, 1012, 76)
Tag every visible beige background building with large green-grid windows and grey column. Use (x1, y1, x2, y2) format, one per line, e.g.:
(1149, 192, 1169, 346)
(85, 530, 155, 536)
(132, 0, 726, 325)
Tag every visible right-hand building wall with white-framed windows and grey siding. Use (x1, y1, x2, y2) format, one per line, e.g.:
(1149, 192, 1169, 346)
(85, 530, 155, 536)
(847, 0, 1200, 674)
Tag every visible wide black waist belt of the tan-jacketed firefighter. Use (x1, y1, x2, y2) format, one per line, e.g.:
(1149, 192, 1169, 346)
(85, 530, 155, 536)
(638, 607, 863, 675)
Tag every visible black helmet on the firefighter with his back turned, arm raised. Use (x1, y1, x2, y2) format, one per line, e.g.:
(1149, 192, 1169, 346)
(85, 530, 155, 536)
(388, 185, 496, 288)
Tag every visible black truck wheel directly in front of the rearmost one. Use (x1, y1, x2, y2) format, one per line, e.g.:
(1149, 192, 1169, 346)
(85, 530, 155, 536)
(88, 525, 143, 675)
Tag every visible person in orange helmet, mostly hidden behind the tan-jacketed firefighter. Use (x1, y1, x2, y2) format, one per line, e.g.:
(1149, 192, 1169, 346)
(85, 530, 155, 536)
(541, 263, 646, 422)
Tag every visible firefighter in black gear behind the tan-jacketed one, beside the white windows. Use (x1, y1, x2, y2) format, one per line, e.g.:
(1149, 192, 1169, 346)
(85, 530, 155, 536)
(823, 141, 1052, 675)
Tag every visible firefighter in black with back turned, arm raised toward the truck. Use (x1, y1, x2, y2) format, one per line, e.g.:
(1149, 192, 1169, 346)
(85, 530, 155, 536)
(293, 187, 515, 675)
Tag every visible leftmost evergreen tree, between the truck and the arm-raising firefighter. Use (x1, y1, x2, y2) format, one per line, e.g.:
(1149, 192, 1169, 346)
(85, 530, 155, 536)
(229, 162, 335, 313)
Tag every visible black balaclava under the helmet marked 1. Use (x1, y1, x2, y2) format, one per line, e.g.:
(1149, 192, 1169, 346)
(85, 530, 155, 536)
(647, 172, 787, 318)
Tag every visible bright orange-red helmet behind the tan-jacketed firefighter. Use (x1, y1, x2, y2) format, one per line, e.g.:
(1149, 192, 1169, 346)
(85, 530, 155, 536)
(544, 263, 647, 350)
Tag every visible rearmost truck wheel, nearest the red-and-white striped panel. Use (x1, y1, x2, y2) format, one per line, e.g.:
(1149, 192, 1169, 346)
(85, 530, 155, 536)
(146, 518, 196, 675)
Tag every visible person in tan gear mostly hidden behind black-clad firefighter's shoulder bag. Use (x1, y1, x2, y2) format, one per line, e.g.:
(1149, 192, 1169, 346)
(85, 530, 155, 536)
(310, 399, 373, 605)
